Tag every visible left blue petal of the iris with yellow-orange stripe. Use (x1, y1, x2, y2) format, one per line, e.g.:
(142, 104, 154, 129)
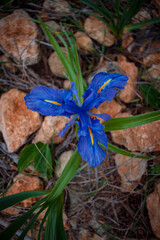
(24, 86, 72, 117)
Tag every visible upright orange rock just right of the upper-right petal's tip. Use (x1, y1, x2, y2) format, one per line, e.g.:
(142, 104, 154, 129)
(118, 55, 138, 103)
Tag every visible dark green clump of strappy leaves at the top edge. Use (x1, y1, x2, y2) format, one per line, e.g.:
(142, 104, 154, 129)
(76, 0, 160, 37)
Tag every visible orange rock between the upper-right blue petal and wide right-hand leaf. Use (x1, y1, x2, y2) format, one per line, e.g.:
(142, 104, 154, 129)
(91, 99, 126, 123)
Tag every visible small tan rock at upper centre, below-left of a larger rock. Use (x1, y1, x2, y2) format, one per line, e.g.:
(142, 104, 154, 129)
(74, 32, 94, 53)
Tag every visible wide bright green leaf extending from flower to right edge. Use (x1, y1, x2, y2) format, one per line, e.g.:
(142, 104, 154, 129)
(104, 110, 160, 132)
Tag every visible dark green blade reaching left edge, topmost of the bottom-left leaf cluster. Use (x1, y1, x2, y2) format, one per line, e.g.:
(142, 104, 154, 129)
(0, 191, 49, 211)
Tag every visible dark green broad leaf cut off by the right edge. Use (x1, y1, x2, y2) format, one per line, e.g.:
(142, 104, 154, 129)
(140, 85, 160, 108)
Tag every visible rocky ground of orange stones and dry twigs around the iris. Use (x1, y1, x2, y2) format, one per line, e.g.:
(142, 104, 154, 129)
(0, 0, 160, 240)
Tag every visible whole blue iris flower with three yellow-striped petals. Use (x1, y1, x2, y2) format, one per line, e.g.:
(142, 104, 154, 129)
(25, 72, 128, 167)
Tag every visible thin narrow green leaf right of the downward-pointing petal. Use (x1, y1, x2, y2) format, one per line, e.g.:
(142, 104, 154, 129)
(107, 143, 150, 159)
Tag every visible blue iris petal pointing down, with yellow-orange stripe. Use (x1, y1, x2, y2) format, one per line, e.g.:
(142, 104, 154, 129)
(78, 113, 107, 167)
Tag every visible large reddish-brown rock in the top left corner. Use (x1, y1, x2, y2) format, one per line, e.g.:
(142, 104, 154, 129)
(0, 9, 40, 65)
